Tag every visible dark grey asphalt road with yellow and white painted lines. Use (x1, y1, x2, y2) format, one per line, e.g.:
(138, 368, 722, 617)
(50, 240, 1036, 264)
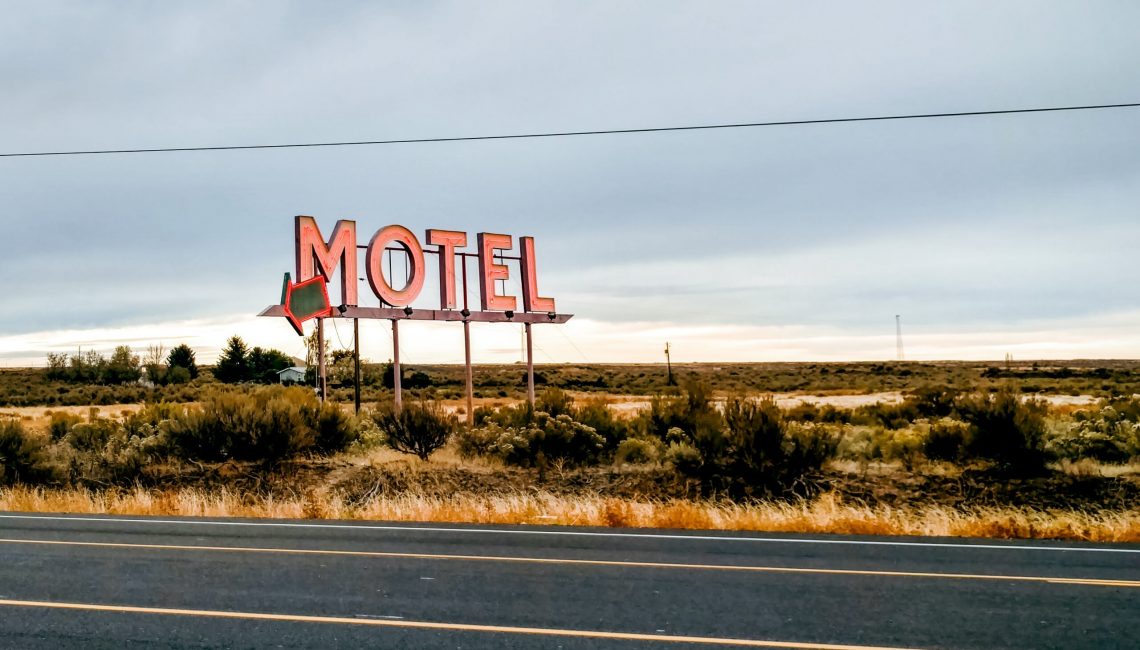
(0, 513, 1140, 649)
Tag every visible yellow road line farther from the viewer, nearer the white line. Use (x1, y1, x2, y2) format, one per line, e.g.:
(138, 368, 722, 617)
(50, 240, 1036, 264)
(0, 538, 1140, 588)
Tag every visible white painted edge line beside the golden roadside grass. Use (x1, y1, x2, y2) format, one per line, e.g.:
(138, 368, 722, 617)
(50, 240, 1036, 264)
(0, 514, 1140, 554)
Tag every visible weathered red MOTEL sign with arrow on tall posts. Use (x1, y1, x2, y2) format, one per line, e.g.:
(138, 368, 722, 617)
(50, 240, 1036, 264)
(259, 216, 571, 415)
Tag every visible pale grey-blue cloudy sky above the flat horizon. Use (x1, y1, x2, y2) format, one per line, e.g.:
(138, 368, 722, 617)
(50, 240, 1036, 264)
(0, 1, 1140, 366)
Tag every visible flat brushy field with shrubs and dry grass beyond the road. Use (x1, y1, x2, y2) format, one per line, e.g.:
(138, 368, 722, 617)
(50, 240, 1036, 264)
(0, 361, 1140, 542)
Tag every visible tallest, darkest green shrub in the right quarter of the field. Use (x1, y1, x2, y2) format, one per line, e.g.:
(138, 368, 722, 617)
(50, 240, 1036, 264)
(955, 388, 1047, 473)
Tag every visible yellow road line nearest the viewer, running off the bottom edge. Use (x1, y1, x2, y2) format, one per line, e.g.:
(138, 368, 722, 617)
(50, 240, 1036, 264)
(0, 600, 907, 650)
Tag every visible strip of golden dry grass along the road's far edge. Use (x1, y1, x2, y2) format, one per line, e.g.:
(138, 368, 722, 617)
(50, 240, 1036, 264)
(0, 487, 1140, 543)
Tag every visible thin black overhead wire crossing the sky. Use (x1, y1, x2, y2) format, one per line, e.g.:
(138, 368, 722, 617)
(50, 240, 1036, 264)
(0, 101, 1140, 157)
